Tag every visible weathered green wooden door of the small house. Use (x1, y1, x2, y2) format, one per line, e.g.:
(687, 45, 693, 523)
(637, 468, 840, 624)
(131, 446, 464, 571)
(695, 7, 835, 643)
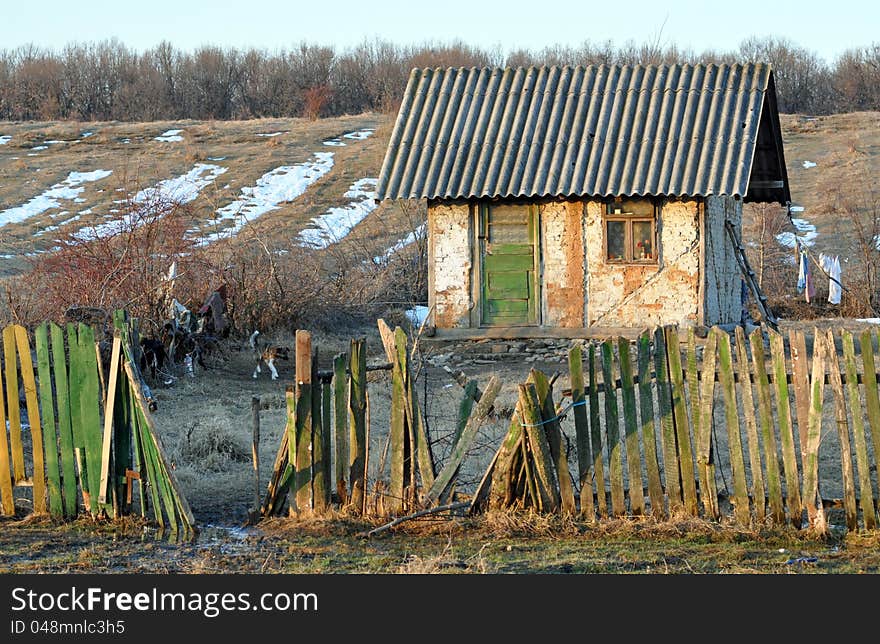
(480, 204, 538, 326)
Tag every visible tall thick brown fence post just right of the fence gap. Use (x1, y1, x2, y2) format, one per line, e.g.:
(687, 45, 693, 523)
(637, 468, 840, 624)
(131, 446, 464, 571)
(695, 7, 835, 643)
(293, 329, 313, 513)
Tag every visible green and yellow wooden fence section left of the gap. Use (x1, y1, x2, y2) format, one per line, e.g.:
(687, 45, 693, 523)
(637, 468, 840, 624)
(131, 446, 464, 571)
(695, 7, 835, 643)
(0, 311, 195, 535)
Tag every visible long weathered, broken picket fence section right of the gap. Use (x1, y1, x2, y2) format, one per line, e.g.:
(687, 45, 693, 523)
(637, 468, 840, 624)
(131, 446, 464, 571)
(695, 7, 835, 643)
(261, 320, 880, 532)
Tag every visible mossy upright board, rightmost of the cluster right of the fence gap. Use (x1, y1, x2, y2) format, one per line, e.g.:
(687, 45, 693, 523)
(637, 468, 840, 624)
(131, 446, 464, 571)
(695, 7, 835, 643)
(348, 338, 367, 514)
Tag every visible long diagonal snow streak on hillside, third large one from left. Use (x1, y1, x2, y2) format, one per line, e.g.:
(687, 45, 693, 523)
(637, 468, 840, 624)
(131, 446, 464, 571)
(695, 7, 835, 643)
(198, 152, 333, 245)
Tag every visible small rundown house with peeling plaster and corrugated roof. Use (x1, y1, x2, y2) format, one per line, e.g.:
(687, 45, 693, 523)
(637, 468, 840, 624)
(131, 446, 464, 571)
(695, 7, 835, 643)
(377, 64, 791, 335)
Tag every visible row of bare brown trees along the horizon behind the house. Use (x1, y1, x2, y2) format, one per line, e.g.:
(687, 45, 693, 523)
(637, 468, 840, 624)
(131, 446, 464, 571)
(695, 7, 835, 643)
(0, 37, 880, 121)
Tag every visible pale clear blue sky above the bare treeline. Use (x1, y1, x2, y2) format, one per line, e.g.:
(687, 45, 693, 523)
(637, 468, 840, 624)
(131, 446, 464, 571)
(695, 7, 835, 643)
(0, 0, 880, 63)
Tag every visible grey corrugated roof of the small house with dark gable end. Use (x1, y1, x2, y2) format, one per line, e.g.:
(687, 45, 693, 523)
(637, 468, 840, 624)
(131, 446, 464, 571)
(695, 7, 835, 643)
(377, 63, 790, 203)
